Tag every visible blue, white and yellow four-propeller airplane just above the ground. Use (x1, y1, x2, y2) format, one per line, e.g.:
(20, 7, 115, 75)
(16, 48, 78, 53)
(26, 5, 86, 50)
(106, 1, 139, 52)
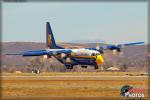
(6, 22, 144, 69)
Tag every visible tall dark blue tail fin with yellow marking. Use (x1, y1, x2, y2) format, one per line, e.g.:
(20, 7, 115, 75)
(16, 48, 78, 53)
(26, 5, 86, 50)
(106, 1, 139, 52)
(46, 22, 63, 49)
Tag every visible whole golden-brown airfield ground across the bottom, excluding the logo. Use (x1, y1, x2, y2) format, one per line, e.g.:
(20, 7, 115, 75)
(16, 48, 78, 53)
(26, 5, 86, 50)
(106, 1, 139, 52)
(1, 72, 148, 100)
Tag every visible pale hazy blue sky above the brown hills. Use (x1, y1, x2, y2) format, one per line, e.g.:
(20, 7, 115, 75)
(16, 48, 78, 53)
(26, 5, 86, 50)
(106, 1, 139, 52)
(2, 2, 148, 43)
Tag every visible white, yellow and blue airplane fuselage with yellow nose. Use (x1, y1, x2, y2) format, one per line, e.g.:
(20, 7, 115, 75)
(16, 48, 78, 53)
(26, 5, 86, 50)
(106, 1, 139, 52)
(47, 48, 103, 66)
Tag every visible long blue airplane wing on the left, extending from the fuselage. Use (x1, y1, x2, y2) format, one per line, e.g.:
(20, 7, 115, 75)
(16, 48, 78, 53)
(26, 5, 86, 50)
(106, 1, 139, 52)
(6, 49, 71, 56)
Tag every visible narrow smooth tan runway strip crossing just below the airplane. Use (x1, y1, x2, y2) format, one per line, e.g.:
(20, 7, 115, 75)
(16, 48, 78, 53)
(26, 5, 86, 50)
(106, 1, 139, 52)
(1, 75, 148, 80)
